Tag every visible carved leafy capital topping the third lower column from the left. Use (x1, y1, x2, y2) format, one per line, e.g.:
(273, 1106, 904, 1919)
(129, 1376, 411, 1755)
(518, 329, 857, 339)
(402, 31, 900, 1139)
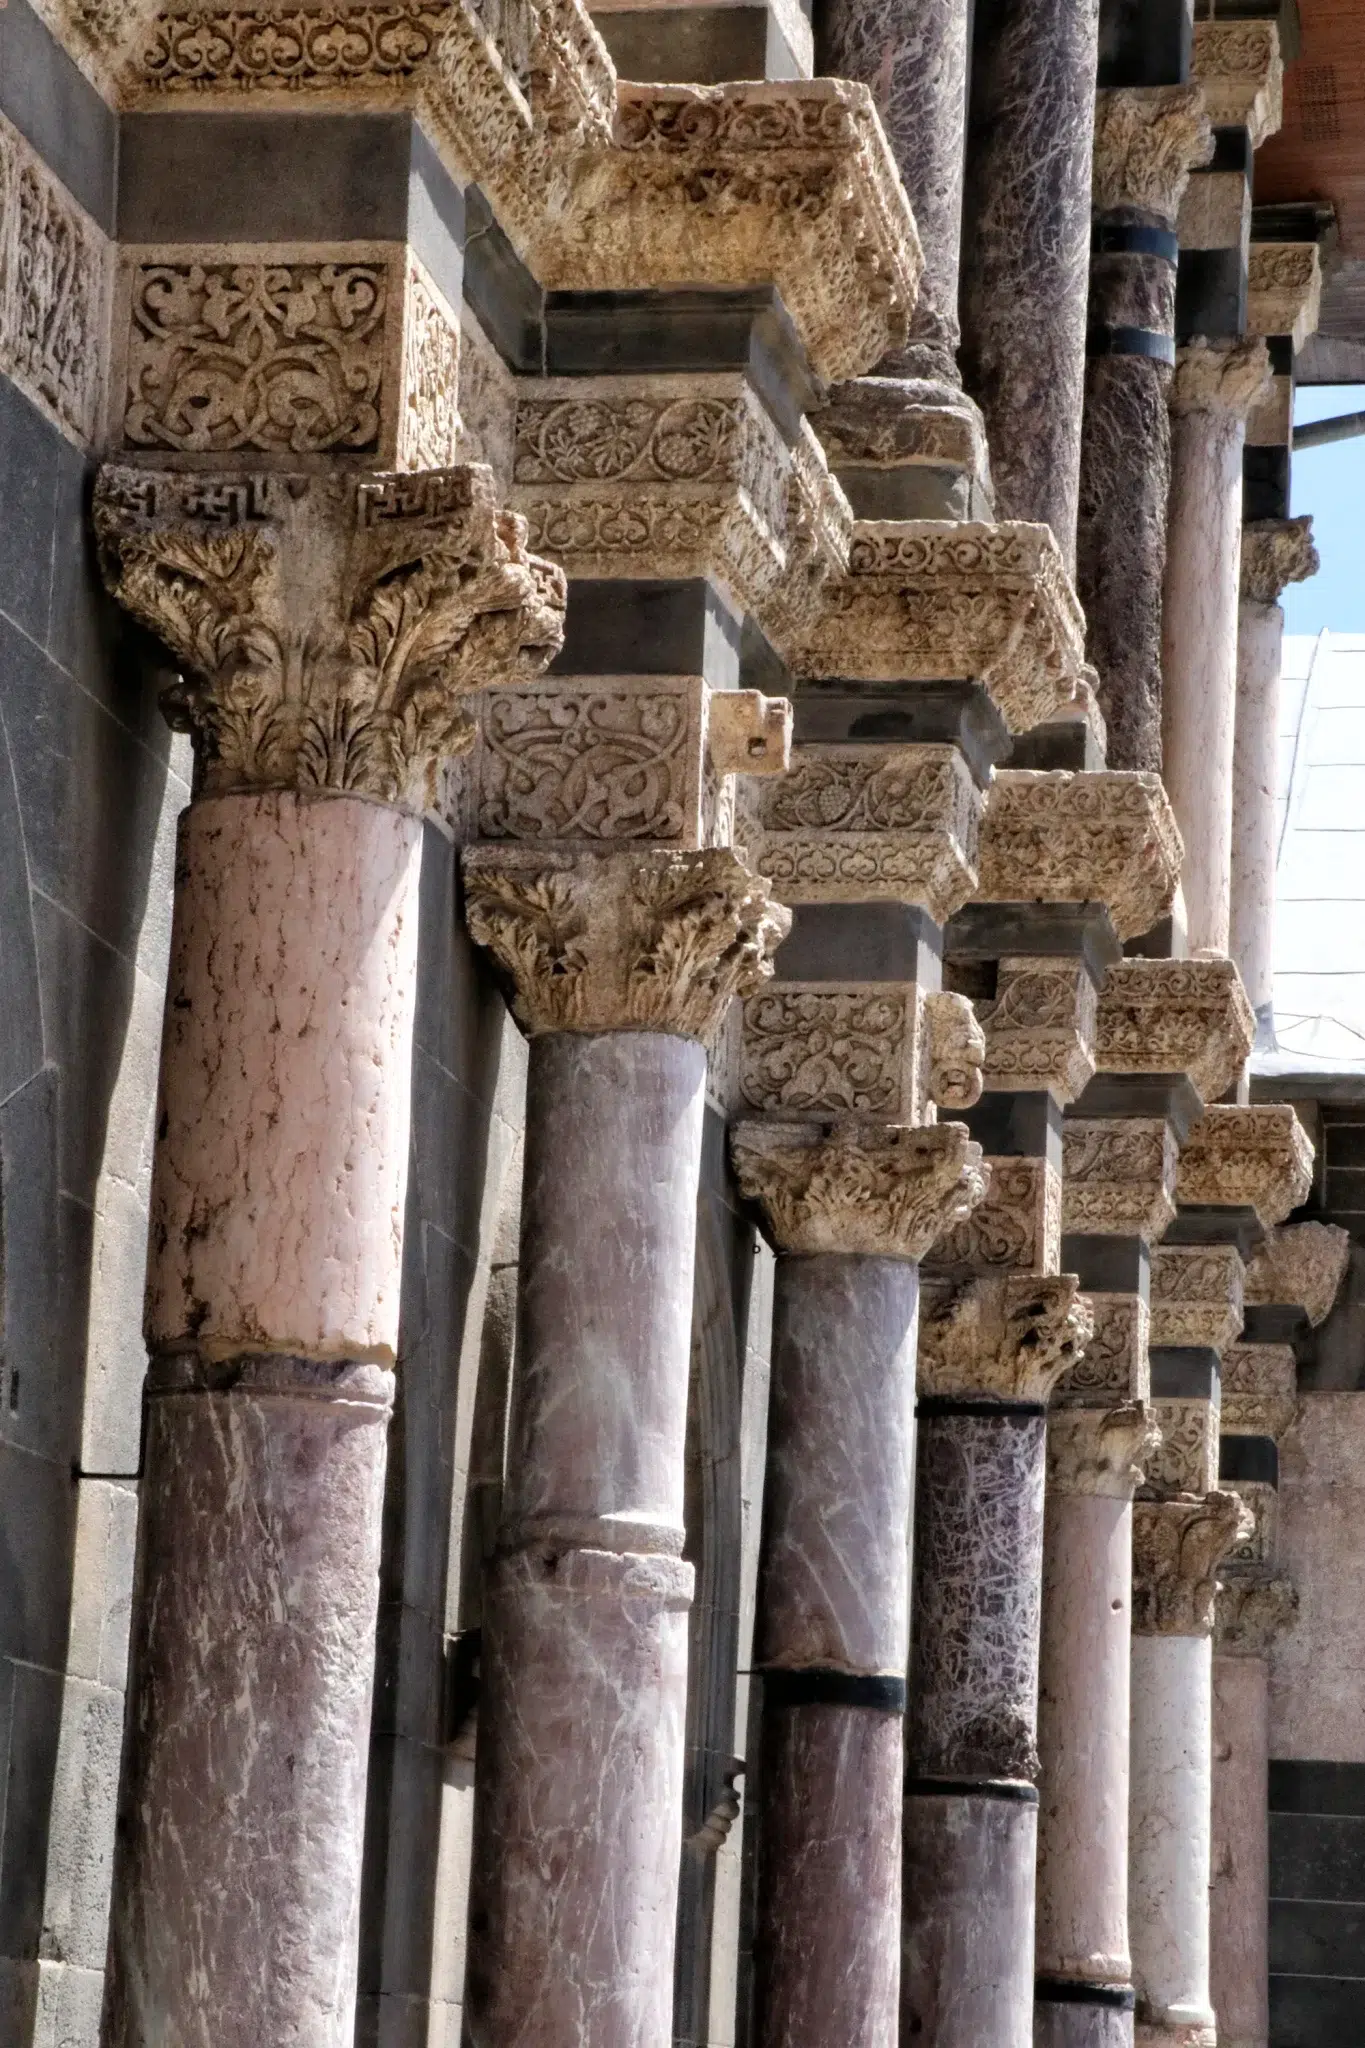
(731, 1118, 984, 1260)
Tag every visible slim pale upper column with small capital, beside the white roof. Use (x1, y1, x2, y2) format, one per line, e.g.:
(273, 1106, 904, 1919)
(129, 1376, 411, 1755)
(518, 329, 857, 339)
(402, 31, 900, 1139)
(1228, 518, 1318, 1044)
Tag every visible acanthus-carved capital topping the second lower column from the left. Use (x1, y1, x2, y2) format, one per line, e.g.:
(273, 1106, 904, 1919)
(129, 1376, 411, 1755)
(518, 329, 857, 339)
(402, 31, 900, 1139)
(463, 846, 790, 1042)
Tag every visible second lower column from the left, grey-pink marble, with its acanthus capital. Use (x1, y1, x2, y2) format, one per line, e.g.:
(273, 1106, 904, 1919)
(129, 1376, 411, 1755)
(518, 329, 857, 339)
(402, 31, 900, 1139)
(465, 846, 786, 2048)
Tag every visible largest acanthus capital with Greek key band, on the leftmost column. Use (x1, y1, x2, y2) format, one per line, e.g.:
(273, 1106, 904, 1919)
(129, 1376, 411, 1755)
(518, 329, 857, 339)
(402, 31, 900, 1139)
(94, 467, 565, 811)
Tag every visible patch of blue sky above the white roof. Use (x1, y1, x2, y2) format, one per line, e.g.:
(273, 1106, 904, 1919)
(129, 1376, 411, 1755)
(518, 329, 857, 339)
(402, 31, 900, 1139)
(1279, 385, 1365, 633)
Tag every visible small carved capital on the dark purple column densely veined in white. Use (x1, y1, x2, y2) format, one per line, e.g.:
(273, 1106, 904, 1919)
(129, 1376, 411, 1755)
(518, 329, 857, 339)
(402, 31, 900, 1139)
(917, 1274, 1091, 1401)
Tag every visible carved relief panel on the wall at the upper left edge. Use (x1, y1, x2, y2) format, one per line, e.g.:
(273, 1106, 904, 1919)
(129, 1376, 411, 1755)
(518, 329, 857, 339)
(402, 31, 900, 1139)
(0, 115, 113, 448)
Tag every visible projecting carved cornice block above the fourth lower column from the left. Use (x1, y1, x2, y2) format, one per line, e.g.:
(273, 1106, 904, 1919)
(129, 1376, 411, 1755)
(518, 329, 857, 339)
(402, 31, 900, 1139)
(976, 768, 1183, 938)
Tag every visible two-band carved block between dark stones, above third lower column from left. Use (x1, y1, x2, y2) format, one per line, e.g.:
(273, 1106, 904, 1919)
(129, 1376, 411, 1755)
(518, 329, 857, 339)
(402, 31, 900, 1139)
(749, 745, 982, 924)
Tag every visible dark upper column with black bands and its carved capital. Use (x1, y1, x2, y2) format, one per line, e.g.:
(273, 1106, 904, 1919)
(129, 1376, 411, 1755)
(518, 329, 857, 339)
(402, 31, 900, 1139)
(1076, 86, 1214, 772)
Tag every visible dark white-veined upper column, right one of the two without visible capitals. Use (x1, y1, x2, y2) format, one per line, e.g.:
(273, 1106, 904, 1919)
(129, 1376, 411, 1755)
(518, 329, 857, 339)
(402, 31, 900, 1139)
(962, 0, 1099, 569)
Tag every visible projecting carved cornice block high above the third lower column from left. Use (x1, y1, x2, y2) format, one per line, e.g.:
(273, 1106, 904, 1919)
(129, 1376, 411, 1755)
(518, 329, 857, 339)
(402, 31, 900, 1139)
(796, 520, 1085, 733)
